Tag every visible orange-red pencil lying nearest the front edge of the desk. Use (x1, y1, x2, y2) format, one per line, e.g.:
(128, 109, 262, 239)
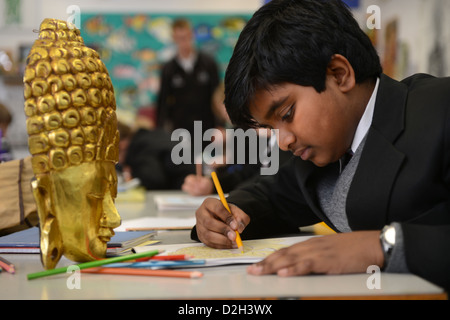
(81, 267, 203, 278)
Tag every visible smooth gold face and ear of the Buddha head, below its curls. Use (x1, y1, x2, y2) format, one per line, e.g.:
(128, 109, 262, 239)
(35, 161, 120, 269)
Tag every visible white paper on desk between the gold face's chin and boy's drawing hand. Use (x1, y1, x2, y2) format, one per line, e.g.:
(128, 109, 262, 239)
(114, 217, 195, 231)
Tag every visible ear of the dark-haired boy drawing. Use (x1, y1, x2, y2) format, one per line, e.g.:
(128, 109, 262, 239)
(327, 54, 356, 93)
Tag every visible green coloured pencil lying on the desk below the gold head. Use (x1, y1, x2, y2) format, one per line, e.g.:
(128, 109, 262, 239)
(27, 250, 162, 280)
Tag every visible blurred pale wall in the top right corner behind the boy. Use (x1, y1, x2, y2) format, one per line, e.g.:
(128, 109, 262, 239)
(355, 0, 450, 79)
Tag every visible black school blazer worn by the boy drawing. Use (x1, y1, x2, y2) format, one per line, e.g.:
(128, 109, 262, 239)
(192, 74, 450, 290)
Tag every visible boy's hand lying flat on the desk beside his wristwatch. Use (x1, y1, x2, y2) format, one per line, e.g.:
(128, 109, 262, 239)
(247, 231, 384, 277)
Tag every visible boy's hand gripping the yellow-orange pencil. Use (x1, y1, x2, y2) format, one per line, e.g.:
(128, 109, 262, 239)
(195, 198, 250, 249)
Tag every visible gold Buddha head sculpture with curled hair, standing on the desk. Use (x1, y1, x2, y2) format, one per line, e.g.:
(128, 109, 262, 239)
(24, 19, 120, 269)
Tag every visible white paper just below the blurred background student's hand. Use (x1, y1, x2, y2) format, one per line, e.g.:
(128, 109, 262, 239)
(154, 194, 219, 211)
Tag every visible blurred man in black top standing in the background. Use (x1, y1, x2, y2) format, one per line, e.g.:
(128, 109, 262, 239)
(157, 19, 219, 142)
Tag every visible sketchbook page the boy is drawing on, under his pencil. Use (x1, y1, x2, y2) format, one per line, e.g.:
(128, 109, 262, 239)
(133, 236, 311, 266)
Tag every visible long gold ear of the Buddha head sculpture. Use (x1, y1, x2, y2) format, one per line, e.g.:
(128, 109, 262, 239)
(31, 176, 63, 269)
